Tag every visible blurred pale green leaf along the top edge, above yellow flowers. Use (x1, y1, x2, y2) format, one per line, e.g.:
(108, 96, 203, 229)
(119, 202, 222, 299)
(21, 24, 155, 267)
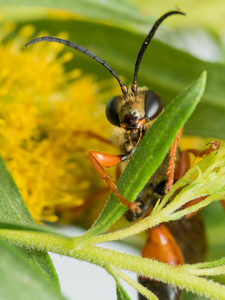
(0, 0, 156, 29)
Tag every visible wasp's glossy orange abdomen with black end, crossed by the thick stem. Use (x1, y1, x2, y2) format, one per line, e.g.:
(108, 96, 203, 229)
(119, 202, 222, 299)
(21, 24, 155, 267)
(139, 224, 184, 300)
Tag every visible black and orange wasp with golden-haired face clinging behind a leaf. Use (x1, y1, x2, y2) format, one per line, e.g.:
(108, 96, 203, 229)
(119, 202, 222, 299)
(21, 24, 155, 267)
(26, 11, 221, 300)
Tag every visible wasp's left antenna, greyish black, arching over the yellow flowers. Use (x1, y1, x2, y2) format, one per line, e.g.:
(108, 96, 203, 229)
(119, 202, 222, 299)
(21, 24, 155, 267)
(25, 36, 128, 95)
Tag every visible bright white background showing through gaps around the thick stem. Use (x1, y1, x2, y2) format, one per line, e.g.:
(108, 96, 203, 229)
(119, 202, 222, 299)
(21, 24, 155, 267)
(50, 227, 139, 300)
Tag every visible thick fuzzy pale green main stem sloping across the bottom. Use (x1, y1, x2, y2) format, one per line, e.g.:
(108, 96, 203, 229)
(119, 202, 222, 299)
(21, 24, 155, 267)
(0, 230, 225, 300)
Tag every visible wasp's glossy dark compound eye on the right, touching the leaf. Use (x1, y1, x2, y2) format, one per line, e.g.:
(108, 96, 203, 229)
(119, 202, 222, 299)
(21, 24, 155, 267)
(145, 91, 164, 121)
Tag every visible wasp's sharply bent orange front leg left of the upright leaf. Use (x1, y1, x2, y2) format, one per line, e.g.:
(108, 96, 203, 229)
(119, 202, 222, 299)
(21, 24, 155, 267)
(88, 151, 141, 213)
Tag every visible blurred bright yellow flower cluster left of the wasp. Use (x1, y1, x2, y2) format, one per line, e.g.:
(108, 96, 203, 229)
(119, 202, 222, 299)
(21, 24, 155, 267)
(0, 23, 116, 221)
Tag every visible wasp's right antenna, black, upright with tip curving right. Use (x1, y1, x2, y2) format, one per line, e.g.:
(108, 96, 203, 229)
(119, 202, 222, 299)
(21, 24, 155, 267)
(131, 11, 185, 94)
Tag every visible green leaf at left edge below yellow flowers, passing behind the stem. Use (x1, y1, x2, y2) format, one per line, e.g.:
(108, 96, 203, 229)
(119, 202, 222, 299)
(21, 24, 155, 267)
(0, 157, 59, 289)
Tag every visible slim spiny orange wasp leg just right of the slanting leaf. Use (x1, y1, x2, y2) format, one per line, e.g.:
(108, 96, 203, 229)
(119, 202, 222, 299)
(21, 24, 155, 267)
(165, 128, 183, 193)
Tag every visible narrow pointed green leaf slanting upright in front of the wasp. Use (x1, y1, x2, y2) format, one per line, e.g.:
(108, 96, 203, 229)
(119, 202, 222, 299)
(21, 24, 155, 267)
(78, 72, 206, 239)
